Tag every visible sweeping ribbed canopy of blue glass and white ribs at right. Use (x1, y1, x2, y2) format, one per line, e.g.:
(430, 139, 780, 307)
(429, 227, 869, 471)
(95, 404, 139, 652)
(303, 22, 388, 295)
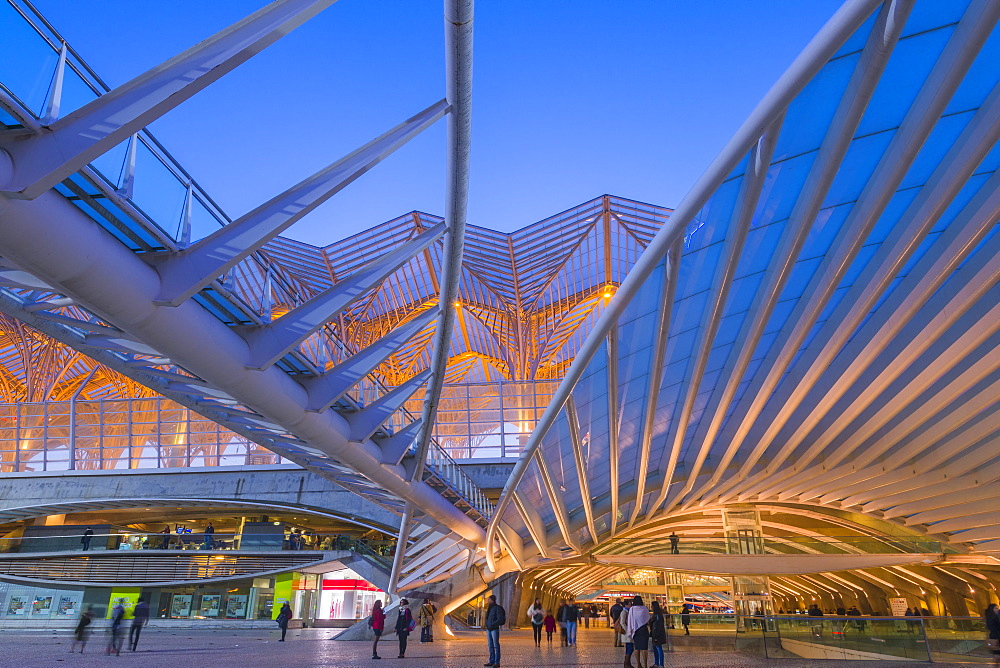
(491, 1, 1000, 561)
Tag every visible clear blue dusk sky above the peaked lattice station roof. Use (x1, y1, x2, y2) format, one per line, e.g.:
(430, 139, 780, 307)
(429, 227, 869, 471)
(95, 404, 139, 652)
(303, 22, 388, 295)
(36, 0, 840, 245)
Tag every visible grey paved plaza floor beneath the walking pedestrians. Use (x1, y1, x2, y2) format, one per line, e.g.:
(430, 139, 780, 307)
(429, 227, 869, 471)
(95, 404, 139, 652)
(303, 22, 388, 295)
(0, 628, 967, 668)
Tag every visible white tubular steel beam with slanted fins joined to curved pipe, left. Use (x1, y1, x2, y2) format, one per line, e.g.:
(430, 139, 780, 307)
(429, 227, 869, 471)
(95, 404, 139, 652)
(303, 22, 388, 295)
(0, 0, 484, 544)
